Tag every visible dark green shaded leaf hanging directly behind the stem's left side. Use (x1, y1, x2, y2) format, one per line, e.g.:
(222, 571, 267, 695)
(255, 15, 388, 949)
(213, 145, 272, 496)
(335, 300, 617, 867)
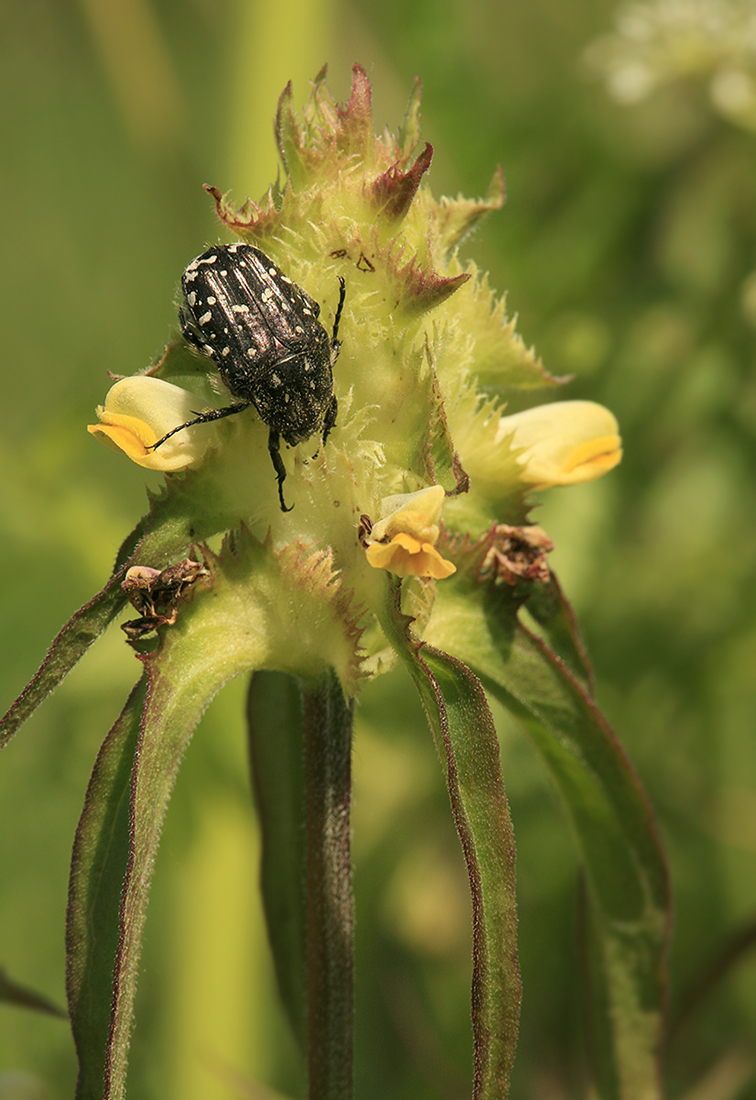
(246, 672, 307, 1054)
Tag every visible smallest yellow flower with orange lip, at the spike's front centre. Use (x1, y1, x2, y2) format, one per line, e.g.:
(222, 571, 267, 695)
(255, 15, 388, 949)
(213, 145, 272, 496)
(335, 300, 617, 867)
(366, 485, 457, 581)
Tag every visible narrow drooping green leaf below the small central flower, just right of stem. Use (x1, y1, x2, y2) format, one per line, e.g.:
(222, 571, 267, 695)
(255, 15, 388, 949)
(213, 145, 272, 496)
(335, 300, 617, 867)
(384, 580, 521, 1100)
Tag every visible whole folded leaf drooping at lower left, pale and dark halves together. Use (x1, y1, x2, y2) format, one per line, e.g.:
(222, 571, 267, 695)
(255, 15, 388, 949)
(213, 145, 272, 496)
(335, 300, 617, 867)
(67, 563, 259, 1100)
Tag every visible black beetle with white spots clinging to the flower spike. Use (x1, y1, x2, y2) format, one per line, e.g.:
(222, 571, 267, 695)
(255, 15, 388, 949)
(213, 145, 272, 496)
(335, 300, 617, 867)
(154, 244, 347, 512)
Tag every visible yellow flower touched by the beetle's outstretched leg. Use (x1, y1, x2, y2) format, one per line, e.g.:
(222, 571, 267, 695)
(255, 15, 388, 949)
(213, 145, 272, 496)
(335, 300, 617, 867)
(87, 374, 215, 472)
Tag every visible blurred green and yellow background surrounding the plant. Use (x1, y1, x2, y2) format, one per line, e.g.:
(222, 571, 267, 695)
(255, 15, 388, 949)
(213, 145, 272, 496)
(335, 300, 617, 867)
(0, 0, 756, 1100)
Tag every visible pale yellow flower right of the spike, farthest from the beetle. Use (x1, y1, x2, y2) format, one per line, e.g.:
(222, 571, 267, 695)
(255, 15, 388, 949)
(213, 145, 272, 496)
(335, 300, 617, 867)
(495, 402, 622, 488)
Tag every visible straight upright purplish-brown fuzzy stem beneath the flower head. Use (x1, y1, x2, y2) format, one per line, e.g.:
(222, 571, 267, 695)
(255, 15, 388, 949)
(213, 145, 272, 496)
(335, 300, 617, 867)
(302, 672, 353, 1100)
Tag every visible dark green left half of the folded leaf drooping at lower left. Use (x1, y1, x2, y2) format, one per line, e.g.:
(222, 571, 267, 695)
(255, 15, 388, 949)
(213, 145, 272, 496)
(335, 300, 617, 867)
(66, 678, 146, 1100)
